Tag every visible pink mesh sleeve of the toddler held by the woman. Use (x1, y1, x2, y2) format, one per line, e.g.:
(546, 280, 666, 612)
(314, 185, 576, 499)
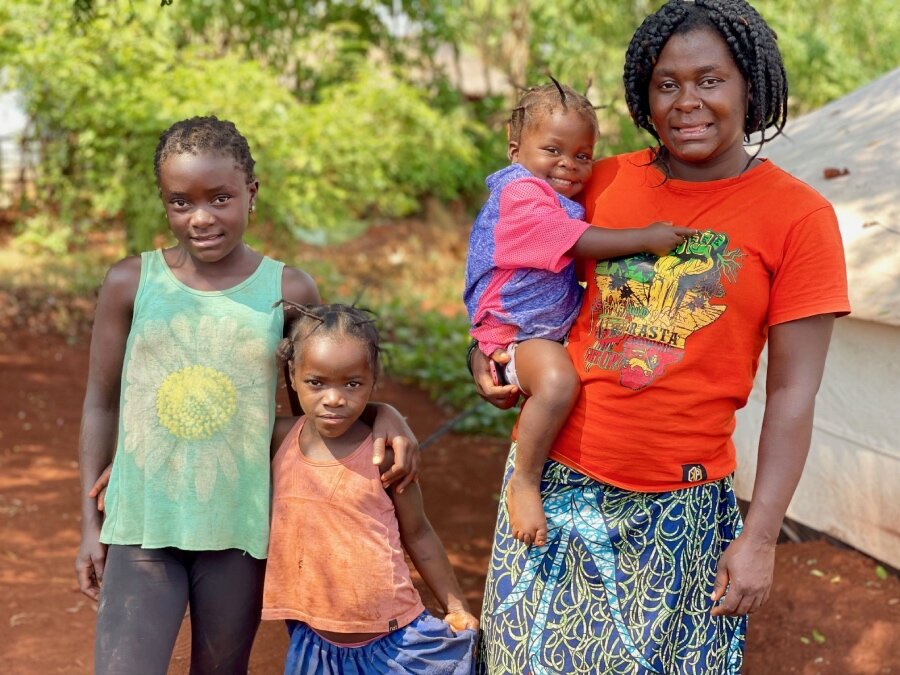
(494, 178, 590, 272)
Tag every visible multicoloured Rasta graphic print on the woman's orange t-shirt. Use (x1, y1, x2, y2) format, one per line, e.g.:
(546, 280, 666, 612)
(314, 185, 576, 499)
(584, 230, 742, 390)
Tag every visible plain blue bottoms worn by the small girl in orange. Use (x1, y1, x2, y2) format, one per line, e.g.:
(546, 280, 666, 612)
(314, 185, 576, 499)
(284, 612, 476, 675)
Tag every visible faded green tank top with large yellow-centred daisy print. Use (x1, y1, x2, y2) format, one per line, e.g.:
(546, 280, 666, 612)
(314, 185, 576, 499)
(100, 250, 284, 558)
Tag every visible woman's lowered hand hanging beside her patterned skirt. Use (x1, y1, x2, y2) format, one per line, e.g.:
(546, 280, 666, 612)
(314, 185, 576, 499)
(710, 531, 775, 616)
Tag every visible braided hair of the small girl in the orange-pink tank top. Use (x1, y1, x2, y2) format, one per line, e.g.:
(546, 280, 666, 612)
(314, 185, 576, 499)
(274, 298, 381, 377)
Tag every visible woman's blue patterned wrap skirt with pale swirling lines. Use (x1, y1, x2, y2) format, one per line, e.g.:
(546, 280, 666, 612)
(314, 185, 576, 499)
(478, 443, 746, 675)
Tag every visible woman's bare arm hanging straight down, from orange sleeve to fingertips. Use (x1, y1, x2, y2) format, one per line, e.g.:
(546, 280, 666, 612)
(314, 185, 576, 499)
(712, 314, 834, 616)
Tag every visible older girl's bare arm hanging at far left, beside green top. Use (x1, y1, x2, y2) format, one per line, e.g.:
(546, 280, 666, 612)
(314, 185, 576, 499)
(75, 257, 141, 600)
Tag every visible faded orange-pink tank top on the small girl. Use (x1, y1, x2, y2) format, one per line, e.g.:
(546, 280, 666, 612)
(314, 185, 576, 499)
(262, 418, 424, 633)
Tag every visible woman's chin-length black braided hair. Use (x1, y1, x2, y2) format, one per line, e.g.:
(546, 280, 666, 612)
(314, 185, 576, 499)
(624, 0, 788, 150)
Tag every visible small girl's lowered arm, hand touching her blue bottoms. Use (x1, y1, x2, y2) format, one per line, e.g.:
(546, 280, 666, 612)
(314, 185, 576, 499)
(388, 483, 478, 631)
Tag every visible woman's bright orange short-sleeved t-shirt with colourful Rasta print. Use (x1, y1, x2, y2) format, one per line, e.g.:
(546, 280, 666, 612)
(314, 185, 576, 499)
(550, 150, 850, 492)
